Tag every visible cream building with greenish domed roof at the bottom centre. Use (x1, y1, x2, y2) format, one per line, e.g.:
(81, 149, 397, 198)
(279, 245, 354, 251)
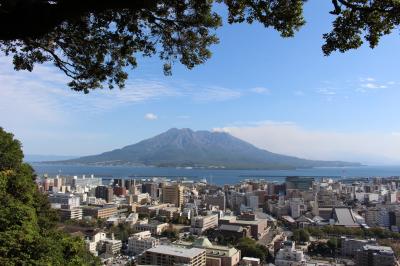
(174, 237, 240, 266)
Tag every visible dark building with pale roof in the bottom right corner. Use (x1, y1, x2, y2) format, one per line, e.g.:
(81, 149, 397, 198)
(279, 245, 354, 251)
(355, 245, 396, 266)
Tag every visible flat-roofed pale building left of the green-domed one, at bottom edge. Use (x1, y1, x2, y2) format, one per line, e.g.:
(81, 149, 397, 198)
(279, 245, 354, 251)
(139, 245, 206, 266)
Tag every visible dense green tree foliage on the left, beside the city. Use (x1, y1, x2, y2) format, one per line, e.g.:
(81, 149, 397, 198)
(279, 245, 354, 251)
(0, 128, 99, 265)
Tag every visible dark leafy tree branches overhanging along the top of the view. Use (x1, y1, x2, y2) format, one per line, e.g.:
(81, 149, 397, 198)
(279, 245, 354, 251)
(0, 0, 400, 93)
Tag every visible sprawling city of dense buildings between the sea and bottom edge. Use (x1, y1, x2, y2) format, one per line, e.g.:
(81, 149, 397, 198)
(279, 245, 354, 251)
(38, 175, 400, 266)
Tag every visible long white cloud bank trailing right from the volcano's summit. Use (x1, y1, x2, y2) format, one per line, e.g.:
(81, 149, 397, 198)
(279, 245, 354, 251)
(214, 122, 400, 164)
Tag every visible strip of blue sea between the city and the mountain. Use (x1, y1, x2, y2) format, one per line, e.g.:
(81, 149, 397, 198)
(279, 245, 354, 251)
(31, 163, 400, 185)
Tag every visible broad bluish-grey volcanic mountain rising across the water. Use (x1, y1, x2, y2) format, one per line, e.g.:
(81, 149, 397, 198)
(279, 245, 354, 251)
(59, 128, 359, 169)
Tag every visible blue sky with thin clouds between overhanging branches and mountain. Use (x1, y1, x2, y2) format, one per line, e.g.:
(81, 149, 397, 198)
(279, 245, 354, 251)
(0, 1, 400, 164)
